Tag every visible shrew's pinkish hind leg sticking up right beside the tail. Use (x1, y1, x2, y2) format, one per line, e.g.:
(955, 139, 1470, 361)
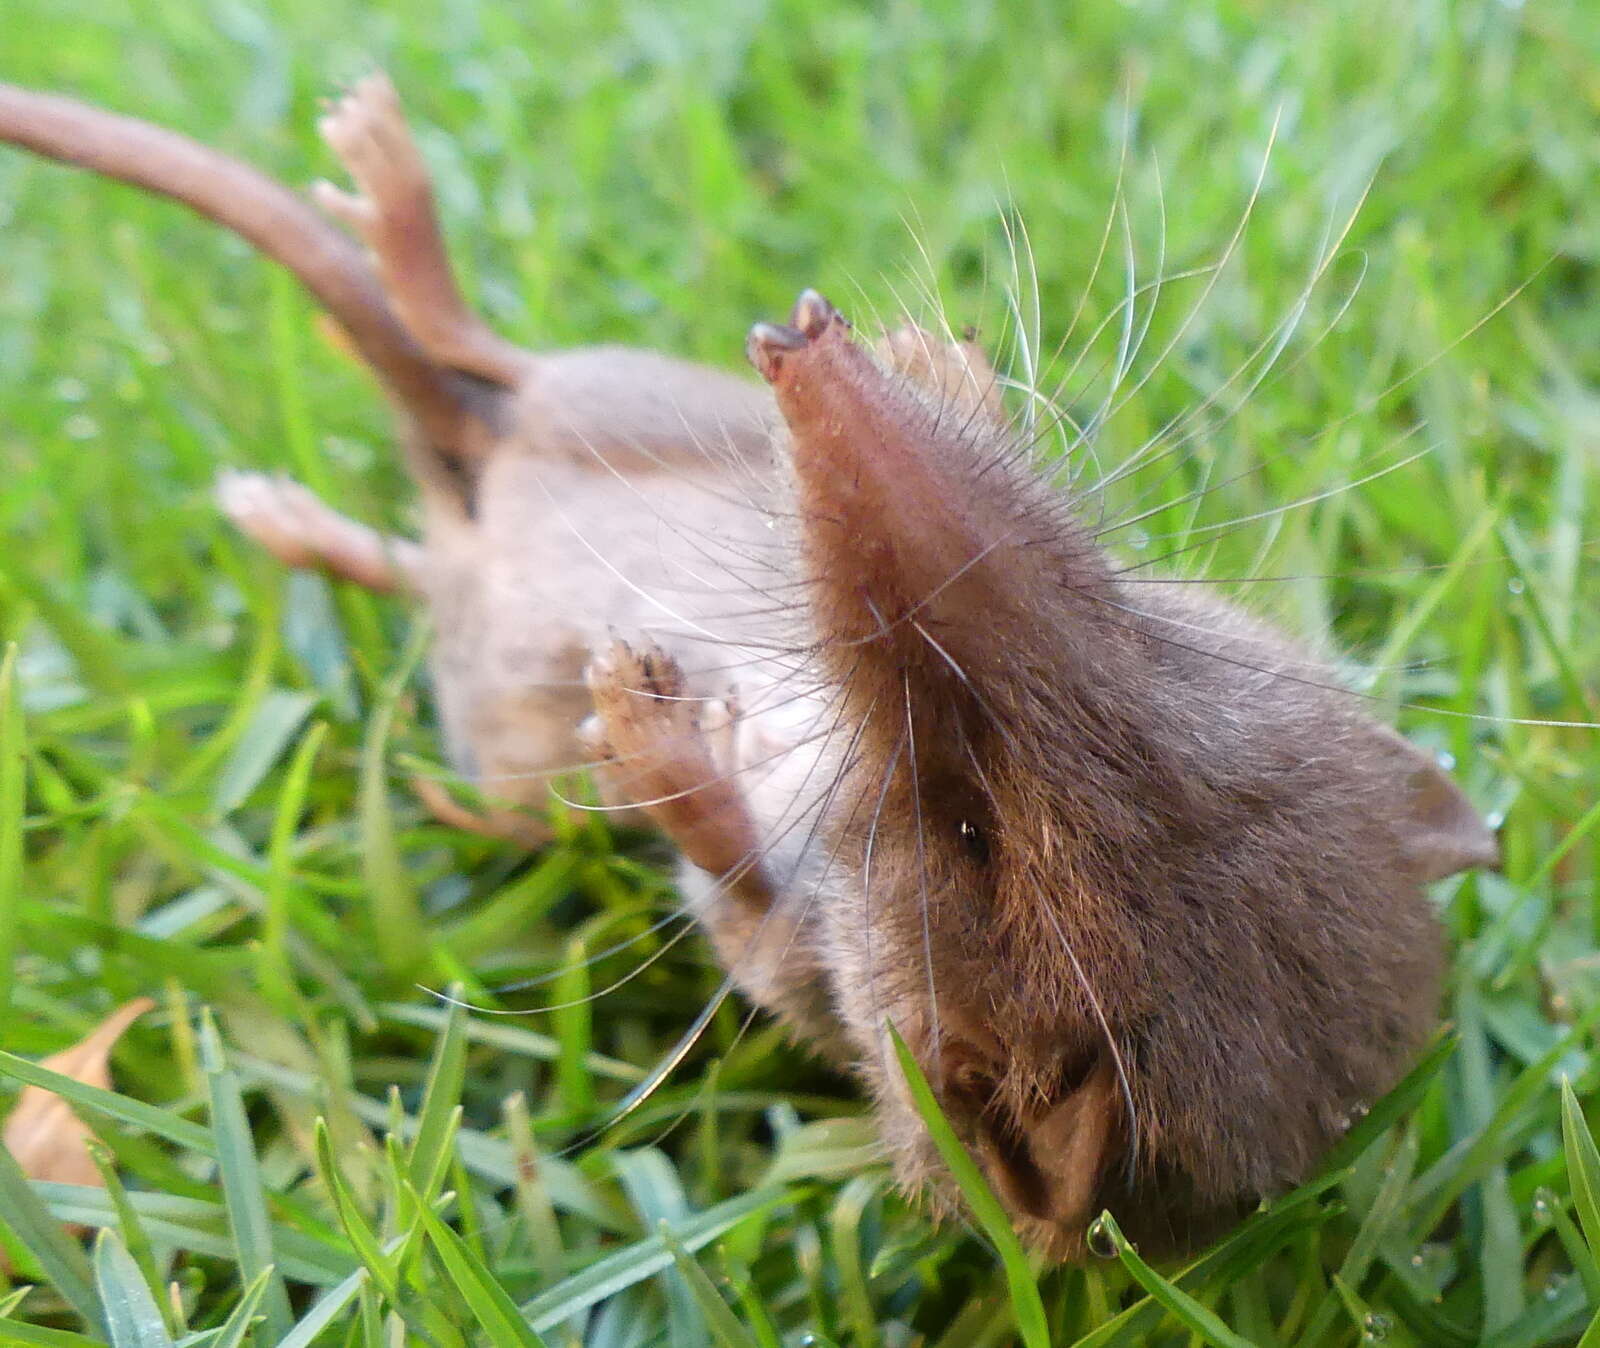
(315, 74, 530, 386)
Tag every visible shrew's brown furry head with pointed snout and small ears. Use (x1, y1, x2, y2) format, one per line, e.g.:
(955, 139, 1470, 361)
(739, 296, 1494, 1252)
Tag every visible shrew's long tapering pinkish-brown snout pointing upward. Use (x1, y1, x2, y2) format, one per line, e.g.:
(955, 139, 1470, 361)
(747, 290, 1104, 704)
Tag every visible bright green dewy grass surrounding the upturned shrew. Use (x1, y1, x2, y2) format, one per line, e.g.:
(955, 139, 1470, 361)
(0, 0, 1600, 1348)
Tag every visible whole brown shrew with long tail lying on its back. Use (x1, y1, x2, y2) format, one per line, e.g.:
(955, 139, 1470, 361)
(0, 80, 1494, 1257)
